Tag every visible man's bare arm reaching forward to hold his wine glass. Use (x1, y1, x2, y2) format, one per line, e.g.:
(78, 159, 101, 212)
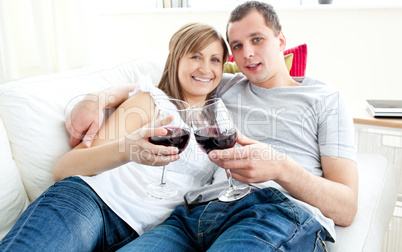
(209, 135, 358, 226)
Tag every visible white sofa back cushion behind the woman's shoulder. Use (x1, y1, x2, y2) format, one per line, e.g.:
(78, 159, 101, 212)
(0, 54, 165, 201)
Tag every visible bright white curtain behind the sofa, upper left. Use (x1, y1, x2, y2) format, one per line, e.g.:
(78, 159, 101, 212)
(0, 0, 91, 84)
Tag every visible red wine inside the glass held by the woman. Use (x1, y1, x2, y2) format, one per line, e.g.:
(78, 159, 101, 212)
(149, 127, 190, 153)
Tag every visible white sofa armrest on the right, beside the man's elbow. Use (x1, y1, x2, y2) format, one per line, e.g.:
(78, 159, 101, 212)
(328, 153, 398, 252)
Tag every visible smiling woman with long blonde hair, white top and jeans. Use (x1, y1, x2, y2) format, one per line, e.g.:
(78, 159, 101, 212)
(0, 23, 228, 251)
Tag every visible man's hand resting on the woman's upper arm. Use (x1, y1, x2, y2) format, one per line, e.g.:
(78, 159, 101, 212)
(65, 95, 105, 148)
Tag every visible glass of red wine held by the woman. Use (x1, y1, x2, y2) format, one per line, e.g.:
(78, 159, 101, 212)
(147, 97, 191, 199)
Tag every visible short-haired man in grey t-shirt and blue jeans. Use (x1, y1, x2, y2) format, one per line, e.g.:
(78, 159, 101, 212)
(69, 1, 357, 251)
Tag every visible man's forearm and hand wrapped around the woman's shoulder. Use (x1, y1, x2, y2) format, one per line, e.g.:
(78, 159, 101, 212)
(65, 84, 135, 147)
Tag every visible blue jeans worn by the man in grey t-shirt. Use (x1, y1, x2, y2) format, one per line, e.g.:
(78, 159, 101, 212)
(119, 188, 325, 252)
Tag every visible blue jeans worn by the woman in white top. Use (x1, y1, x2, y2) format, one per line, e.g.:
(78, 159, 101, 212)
(0, 177, 138, 252)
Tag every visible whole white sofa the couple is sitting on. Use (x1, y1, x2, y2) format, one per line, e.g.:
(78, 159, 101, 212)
(0, 55, 397, 252)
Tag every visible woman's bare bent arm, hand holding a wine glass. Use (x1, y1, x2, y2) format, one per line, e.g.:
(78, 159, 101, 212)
(53, 93, 179, 181)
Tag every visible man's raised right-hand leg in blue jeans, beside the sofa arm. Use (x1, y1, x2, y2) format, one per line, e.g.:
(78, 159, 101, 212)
(208, 188, 325, 251)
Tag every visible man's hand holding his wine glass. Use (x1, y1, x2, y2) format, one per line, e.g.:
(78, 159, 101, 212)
(208, 132, 290, 183)
